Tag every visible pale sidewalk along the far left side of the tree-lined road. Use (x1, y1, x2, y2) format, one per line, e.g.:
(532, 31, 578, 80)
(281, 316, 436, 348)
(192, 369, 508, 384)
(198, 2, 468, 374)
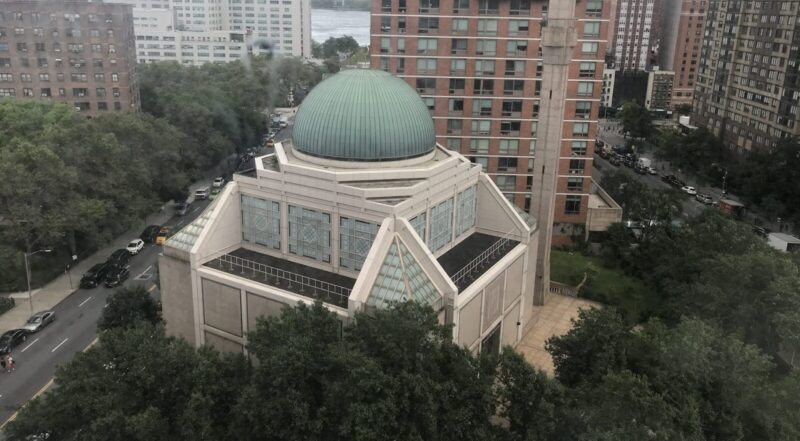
(0, 170, 227, 333)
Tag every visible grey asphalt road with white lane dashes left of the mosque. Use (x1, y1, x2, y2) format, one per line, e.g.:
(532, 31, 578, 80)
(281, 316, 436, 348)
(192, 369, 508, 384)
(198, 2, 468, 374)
(0, 200, 209, 422)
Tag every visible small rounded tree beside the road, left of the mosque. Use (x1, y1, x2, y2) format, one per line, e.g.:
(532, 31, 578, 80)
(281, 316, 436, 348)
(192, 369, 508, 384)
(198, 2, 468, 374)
(97, 285, 161, 331)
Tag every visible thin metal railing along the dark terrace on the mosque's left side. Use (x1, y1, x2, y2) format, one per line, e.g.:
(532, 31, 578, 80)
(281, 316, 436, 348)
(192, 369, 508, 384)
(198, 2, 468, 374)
(209, 254, 352, 308)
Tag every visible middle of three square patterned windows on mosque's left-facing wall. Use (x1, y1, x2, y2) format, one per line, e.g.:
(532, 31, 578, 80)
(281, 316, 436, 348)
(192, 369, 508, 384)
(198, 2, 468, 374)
(289, 205, 331, 262)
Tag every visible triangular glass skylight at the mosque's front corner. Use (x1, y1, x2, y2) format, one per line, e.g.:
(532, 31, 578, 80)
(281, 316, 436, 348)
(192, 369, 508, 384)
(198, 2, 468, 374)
(367, 237, 439, 308)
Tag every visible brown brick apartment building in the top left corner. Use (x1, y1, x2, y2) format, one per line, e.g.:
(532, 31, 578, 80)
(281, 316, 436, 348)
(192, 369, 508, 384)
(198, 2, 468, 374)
(0, 0, 139, 116)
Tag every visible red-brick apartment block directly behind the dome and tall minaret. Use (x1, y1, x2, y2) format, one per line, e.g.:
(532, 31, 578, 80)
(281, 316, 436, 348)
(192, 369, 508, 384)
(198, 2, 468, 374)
(371, 0, 615, 243)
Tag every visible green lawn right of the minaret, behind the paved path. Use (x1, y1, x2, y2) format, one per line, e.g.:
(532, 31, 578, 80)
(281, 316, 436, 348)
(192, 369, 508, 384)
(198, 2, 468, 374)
(550, 250, 657, 322)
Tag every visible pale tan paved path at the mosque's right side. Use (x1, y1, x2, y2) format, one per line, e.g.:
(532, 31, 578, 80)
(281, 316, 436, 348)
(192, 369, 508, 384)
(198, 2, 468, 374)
(516, 294, 602, 377)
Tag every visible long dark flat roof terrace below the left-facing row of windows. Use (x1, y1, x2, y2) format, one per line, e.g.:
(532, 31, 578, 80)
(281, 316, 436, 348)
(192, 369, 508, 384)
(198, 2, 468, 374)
(205, 248, 356, 308)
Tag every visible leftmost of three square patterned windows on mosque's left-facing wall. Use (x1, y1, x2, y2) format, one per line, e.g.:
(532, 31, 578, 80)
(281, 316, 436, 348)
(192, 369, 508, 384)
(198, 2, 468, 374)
(242, 194, 281, 250)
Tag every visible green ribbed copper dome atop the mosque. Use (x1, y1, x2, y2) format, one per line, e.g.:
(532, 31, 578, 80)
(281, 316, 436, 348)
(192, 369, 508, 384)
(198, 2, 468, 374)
(292, 69, 436, 162)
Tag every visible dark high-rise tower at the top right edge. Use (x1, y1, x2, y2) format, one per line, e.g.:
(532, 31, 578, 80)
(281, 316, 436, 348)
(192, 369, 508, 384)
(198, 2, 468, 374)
(693, 0, 800, 153)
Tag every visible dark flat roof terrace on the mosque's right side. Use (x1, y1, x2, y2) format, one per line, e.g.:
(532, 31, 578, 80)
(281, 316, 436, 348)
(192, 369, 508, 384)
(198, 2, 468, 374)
(437, 233, 519, 292)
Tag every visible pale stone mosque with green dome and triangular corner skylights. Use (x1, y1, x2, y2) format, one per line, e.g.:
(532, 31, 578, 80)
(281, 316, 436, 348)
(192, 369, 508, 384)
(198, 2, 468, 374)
(159, 69, 539, 352)
